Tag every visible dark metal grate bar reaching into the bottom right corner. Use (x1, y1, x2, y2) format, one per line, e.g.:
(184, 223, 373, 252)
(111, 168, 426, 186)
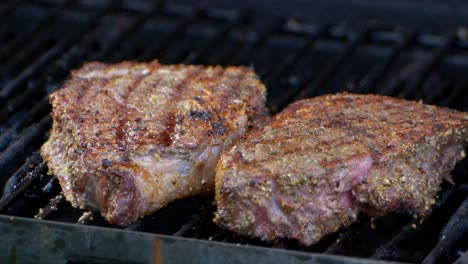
(423, 199, 468, 264)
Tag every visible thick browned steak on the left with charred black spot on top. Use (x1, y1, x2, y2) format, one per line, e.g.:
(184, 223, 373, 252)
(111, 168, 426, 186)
(41, 61, 266, 226)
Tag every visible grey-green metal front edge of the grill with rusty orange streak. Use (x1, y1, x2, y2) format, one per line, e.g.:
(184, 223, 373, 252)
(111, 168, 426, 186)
(0, 215, 402, 264)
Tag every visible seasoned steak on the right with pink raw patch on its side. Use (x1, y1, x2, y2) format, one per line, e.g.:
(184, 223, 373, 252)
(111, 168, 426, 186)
(214, 94, 468, 245)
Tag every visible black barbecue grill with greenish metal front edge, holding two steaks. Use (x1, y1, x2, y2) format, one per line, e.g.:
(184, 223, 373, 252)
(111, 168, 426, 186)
(0, 0, 468, 263)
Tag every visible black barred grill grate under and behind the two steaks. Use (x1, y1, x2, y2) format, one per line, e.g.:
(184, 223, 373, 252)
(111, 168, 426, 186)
(0, 1, 468, 263)
